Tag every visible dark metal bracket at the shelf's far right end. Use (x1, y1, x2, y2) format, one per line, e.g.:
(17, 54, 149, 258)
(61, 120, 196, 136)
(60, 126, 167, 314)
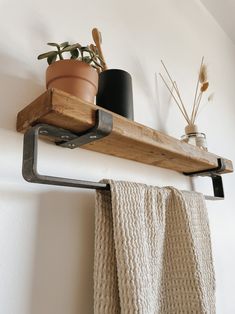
(184, 158, 225, 200)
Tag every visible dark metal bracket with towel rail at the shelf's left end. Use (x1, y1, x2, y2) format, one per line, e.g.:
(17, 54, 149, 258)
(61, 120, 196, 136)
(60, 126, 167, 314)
(22, 110, 113, 189)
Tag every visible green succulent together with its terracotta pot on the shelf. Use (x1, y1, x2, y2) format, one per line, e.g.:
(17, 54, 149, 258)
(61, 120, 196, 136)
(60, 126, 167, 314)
(38, 42, 103, 103)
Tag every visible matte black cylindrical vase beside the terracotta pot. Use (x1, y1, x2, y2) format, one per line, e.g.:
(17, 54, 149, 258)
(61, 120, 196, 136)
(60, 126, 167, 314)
(96, 69, 134, 120)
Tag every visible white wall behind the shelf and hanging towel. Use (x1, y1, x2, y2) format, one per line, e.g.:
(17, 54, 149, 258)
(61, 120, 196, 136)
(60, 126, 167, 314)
(0, 0, 235, 314)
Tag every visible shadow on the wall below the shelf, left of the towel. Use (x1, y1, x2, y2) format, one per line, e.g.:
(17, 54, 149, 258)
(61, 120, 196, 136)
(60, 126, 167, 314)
(30, 191, 95, 314)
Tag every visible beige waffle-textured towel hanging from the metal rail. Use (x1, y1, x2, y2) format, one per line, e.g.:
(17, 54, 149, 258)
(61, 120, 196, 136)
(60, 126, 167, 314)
(94, 181, 215, 314)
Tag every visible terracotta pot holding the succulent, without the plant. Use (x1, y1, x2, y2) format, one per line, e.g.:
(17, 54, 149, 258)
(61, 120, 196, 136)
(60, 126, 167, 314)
(46, 60, 98, 103)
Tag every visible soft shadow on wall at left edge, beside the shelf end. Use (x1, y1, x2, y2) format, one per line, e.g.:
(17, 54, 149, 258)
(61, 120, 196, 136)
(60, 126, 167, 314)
(0, 55, 45, 130)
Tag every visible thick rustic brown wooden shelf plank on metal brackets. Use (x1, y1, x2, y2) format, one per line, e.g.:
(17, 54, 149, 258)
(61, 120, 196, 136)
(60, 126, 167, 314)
(17, 89, 233, 173)
